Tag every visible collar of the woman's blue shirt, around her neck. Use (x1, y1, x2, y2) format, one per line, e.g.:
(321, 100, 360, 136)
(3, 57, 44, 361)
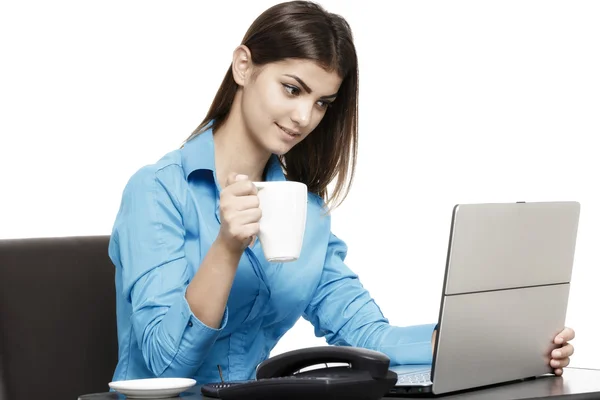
(181, 123, 286, 181)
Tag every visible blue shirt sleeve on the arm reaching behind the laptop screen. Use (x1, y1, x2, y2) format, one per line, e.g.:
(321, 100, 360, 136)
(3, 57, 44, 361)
(303, 234, 435, 365)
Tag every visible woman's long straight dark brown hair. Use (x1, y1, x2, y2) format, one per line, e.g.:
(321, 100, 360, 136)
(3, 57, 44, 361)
(187, 1, 358, 209)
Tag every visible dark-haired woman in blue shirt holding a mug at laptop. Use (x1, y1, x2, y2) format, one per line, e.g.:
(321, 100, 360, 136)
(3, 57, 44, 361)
(109, 1, 573, 383)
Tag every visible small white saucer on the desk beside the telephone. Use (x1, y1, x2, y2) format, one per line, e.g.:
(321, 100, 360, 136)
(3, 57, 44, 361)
(108, 378, 196, 399)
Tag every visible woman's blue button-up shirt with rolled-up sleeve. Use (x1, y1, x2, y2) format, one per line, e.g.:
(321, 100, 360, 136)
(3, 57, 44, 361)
(109, 129, 434, 383)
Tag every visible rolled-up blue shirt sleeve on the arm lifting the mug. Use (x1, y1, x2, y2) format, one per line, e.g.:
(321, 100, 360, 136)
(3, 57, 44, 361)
(111, 168, 228, 377)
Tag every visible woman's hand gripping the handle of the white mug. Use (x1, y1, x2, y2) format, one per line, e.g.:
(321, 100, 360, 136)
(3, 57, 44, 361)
(217, 173, 262, 254)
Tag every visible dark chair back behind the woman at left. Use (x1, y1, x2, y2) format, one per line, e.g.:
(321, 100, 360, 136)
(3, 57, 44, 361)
(0, 236, 117, 400)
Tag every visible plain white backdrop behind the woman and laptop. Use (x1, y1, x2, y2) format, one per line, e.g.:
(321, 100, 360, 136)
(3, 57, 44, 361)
(0, 0, 600, 368)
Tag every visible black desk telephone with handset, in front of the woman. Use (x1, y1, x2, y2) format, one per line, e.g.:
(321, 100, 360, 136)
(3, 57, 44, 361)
(201, 346, 398, 400)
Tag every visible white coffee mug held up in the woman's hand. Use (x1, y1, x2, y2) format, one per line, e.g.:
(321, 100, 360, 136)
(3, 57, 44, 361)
(254, 181, 308, 263)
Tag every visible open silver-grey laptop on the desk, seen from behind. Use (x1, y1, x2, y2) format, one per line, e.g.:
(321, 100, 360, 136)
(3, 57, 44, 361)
(387, 202, 580, 397)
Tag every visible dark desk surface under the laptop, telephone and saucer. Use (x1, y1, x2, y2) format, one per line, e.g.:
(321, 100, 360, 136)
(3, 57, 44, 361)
(77, 368, 600, 400)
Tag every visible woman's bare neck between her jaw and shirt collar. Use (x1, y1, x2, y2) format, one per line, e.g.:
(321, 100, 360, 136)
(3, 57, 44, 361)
(214, 101, 271, 188)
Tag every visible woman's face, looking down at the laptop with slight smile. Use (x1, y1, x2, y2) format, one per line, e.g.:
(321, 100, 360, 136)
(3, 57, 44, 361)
(241, 59, 342, 155)
